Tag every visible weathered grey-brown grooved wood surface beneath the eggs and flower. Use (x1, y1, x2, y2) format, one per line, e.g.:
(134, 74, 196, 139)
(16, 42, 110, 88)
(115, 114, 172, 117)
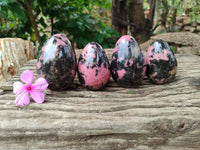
(0, 50, 200, 150)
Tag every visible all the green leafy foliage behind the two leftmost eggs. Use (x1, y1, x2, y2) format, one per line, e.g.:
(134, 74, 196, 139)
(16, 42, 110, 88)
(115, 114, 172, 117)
(0, 0, 120, 48)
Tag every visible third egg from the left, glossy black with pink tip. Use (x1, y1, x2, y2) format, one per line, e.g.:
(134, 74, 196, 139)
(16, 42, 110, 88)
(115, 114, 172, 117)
(111, 35, 146, 86)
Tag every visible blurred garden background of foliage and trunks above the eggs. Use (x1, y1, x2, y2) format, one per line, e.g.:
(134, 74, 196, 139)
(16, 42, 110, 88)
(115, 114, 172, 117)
(0, 0, 200, 49)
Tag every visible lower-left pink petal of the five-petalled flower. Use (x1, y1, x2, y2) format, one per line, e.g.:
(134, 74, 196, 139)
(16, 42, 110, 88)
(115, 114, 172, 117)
(15, 91, 30, 106)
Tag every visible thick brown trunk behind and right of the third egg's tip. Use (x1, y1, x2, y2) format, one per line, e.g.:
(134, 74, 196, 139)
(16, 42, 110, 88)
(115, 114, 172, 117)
(129, 0, 147, 43)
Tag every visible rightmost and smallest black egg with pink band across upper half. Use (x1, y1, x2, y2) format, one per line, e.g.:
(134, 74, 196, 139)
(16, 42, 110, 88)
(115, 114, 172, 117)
(146, 39, 177, 84)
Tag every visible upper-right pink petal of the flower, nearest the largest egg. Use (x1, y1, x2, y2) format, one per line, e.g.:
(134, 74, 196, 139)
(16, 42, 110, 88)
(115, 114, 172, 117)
(32, 77, 49, 91)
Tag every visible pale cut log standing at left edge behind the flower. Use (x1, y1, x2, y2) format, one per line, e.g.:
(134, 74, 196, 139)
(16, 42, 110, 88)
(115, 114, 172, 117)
(0, 38, 37, 82)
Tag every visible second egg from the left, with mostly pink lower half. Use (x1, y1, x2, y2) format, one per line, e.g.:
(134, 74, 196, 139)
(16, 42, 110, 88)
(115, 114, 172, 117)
(78, 42, 111, 90)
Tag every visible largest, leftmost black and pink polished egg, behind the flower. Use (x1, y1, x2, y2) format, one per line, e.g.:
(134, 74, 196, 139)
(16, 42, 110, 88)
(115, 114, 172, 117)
(37, 34, 77, 90)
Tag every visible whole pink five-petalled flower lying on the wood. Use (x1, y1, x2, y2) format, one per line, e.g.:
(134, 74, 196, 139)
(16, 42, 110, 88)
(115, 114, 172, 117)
(13, 70, 48, 106)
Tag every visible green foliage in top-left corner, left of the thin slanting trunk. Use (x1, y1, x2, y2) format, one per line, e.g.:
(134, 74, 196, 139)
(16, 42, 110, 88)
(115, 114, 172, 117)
(0, 0, 33, 39)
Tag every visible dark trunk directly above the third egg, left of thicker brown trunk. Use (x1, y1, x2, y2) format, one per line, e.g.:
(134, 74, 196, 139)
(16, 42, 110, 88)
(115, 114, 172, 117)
(112, 0, 128, 35)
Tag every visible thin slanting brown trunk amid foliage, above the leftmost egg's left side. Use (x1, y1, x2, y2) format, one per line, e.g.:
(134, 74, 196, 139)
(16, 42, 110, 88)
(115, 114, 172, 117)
(25, 0, 42, 43)
